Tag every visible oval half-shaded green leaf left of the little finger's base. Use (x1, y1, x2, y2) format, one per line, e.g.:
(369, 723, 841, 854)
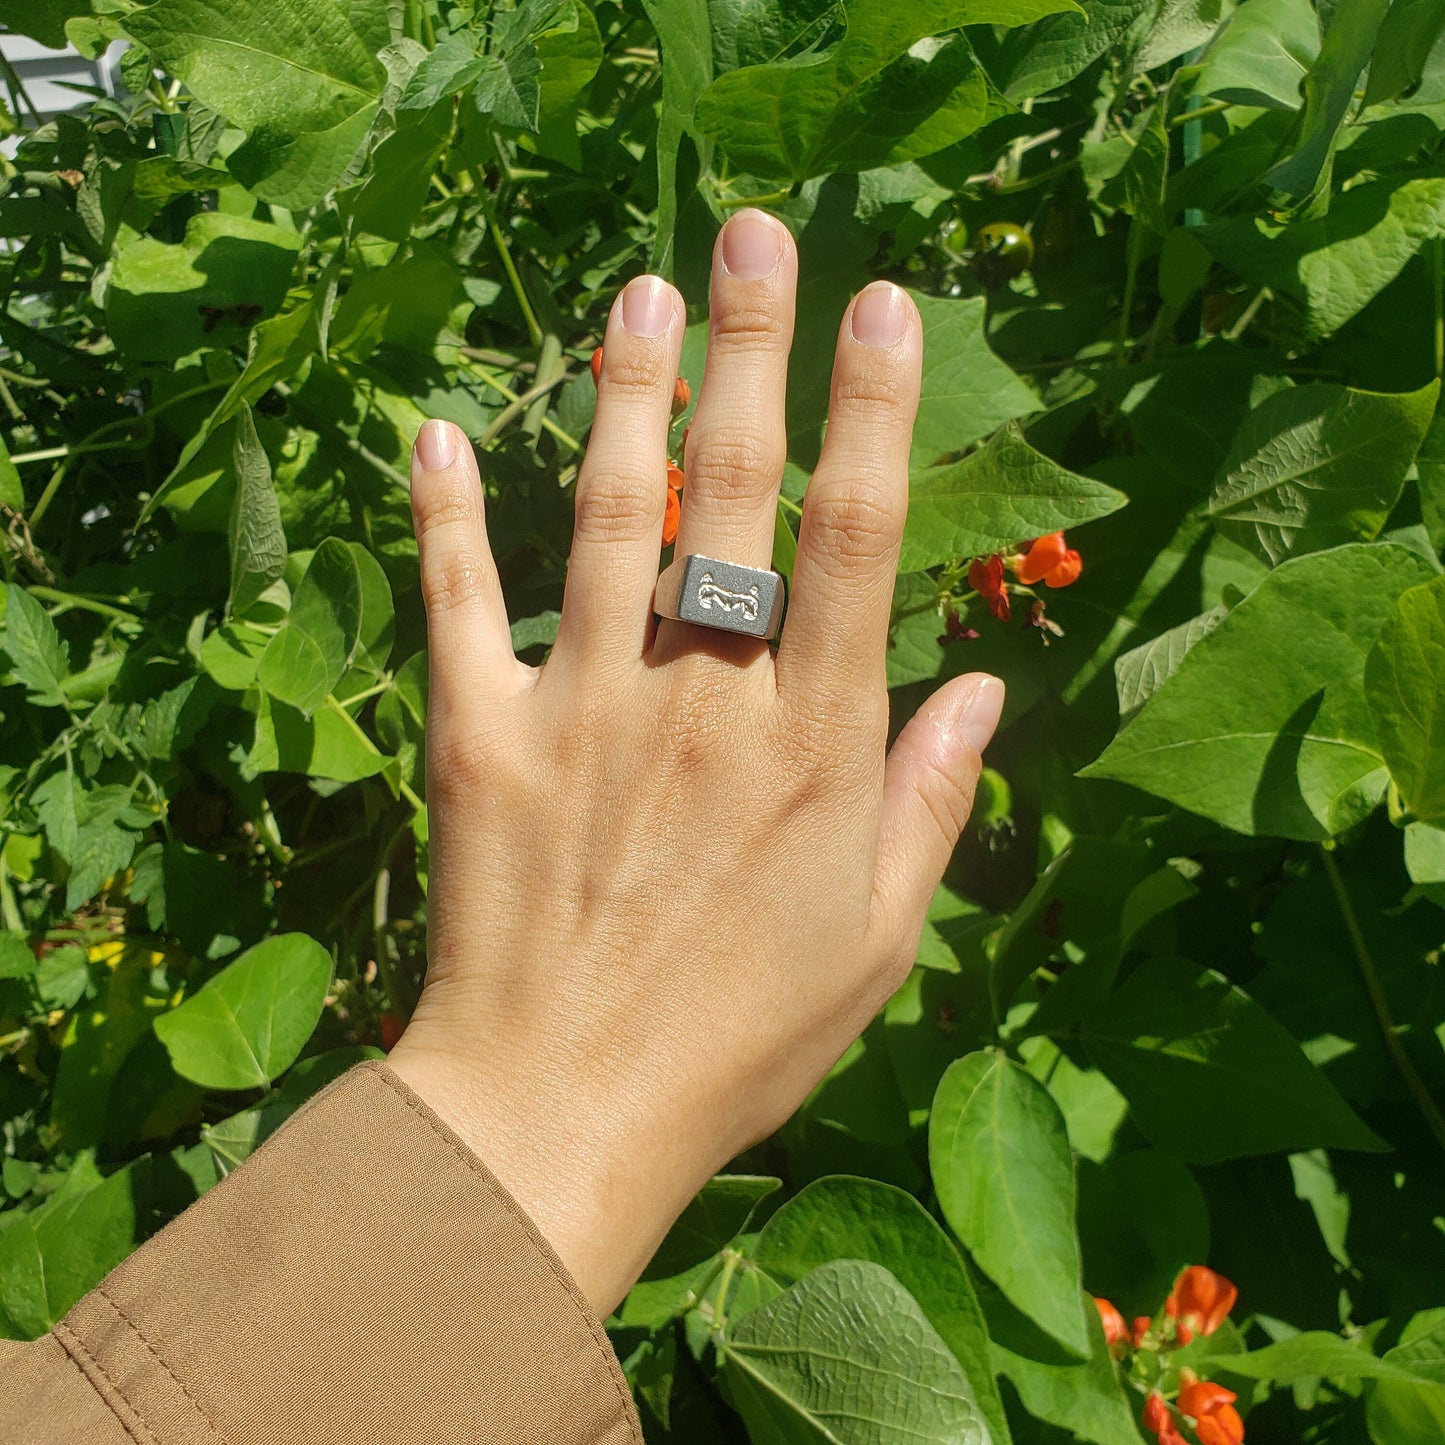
(256, 538, 361, 717)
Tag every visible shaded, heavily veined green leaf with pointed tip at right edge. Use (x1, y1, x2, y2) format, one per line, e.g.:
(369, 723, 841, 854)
(1209, 381, 1439, 564)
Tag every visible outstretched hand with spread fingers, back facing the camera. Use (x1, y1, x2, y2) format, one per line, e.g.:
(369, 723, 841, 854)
(390, 211, 1003, 1316)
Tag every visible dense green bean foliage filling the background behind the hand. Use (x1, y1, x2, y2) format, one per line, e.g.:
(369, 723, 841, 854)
(0, 0, 1445, 1445)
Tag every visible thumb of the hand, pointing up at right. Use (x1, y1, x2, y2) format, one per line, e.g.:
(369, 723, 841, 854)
(873, 672, 1004, 938)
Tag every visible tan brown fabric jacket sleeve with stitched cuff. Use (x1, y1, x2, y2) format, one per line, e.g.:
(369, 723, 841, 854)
(0, 1064, 642, 1445)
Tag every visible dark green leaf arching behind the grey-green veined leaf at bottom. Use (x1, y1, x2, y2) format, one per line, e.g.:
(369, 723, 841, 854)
(751, 1175, 1009, 1445)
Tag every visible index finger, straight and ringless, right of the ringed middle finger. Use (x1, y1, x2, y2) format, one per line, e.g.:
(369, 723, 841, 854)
(777, 282, 923, 709)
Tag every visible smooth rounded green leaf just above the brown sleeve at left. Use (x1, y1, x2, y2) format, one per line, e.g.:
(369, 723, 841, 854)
(155, 933, 331, 1088)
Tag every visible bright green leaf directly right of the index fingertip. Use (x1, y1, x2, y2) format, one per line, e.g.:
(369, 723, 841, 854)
(912, 292, 1039, 468)
